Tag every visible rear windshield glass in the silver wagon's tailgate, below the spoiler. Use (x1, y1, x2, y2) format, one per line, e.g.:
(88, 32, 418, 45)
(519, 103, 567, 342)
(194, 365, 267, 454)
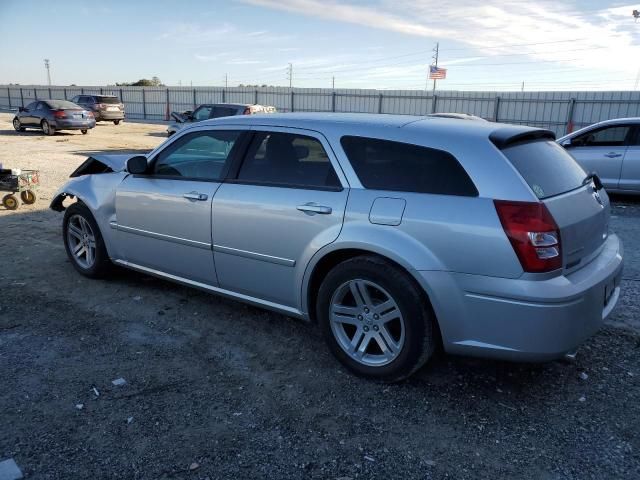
(502, 141, 586, 199)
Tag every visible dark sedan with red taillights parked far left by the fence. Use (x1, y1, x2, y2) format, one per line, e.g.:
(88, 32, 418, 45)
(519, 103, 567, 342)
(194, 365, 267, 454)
(13, 100, 96, 135)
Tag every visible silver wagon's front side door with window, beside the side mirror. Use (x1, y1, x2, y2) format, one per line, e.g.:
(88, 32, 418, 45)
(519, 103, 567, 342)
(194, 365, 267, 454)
(112, 129, 241, 285)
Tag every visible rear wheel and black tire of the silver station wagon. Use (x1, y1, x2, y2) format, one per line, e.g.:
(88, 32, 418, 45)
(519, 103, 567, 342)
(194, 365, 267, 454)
(316, 256, 438, 382)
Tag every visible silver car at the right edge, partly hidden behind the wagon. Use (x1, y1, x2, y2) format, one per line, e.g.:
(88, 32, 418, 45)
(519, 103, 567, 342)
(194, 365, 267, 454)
(558, 118, 640, 194)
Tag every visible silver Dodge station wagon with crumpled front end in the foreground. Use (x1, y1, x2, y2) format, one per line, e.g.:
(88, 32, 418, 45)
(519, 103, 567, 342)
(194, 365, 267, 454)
(51, 113, 622, 381)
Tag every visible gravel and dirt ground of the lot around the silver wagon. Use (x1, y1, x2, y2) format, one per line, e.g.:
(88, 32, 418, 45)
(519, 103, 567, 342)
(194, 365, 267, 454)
(0, 114, 640, 480)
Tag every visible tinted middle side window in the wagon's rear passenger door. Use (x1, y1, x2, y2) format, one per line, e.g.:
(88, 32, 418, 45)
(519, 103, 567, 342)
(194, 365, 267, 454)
(238, 132, 342, 189)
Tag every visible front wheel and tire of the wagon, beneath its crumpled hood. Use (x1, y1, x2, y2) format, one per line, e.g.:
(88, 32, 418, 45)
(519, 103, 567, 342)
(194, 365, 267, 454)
(62, 202, 112, 278)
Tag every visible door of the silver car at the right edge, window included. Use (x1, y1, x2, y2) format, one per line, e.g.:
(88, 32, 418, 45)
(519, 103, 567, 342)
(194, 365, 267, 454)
(567, 124, 633, 190)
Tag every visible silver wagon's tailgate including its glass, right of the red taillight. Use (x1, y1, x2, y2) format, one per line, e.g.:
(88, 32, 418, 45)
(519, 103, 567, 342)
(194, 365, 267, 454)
(503, 140, 609, 270)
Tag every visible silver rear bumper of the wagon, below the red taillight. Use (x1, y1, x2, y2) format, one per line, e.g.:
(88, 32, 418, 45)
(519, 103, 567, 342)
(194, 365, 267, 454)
(419, 235, 623, 361)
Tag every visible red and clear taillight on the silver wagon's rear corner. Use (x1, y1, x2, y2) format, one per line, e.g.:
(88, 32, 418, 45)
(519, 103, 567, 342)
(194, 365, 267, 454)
(494, 200, 562, 273)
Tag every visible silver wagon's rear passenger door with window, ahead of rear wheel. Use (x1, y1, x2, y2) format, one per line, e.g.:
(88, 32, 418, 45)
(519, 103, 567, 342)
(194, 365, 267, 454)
(213, 127, 347, 308)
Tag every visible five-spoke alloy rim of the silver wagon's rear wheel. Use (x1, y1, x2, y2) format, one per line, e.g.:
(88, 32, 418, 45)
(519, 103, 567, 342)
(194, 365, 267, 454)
(329, 279, 405, 367)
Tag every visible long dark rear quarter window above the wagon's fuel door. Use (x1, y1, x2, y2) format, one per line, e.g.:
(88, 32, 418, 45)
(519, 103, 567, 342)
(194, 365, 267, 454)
(340, 136, 478, 197)
